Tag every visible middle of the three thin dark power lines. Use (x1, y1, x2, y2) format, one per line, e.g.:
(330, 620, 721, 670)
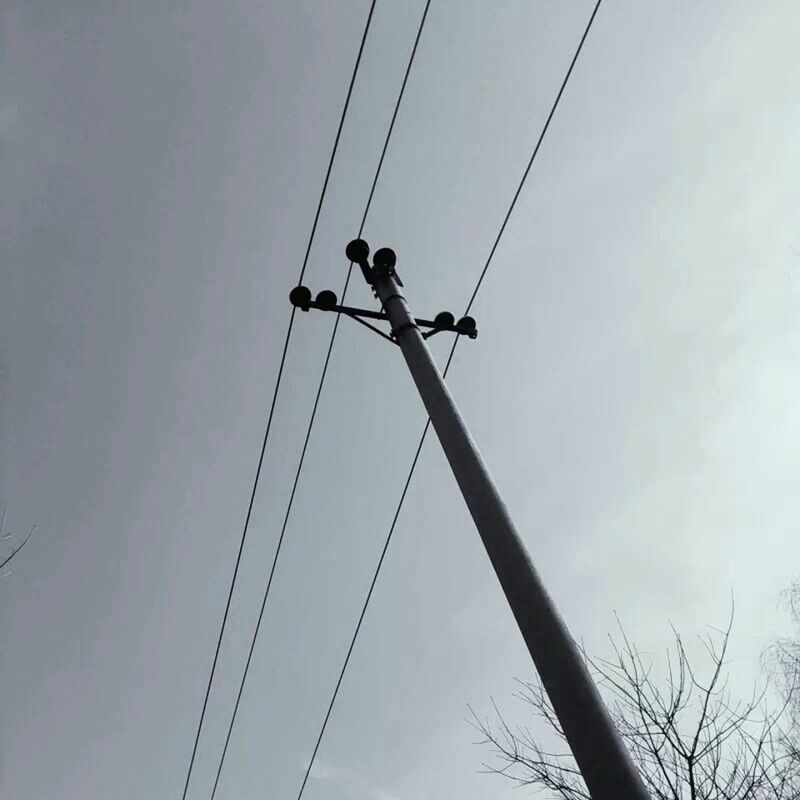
(206, 0, 431, 800)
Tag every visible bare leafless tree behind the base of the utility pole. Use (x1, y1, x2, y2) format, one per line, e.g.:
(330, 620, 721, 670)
(473, 615, 800, 800)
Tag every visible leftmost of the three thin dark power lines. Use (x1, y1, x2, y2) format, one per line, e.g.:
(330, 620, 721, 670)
(182, 0, 377, 800)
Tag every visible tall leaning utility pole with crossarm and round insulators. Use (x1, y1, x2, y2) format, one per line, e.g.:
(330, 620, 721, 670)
(290, 239, 649, 800)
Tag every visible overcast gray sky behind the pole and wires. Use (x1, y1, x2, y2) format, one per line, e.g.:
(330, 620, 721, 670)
(0, 0, 800, 800)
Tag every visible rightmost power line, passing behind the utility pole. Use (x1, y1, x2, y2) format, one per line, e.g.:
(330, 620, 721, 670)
(297, 0, 602, 800)
